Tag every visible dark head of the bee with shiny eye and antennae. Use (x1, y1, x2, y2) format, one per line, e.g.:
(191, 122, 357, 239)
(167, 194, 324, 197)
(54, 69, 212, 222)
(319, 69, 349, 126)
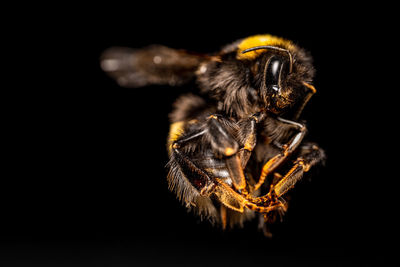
(242, 46, 315, 118)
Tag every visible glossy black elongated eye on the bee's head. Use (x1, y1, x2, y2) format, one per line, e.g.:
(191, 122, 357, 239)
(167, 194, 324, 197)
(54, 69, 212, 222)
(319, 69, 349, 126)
(265, 56, 288, 92)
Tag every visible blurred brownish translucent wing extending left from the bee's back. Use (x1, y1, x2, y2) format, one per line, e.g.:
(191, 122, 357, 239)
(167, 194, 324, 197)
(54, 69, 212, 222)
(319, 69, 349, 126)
(101, 45, 208, 87)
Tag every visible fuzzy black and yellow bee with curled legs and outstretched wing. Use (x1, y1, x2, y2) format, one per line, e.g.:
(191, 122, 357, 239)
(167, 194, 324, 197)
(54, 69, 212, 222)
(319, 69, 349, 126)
(101, 34, 325, 235)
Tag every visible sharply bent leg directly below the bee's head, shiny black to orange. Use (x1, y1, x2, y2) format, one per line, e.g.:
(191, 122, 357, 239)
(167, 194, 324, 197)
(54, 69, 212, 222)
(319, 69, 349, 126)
(254, 117, 306, 190)
